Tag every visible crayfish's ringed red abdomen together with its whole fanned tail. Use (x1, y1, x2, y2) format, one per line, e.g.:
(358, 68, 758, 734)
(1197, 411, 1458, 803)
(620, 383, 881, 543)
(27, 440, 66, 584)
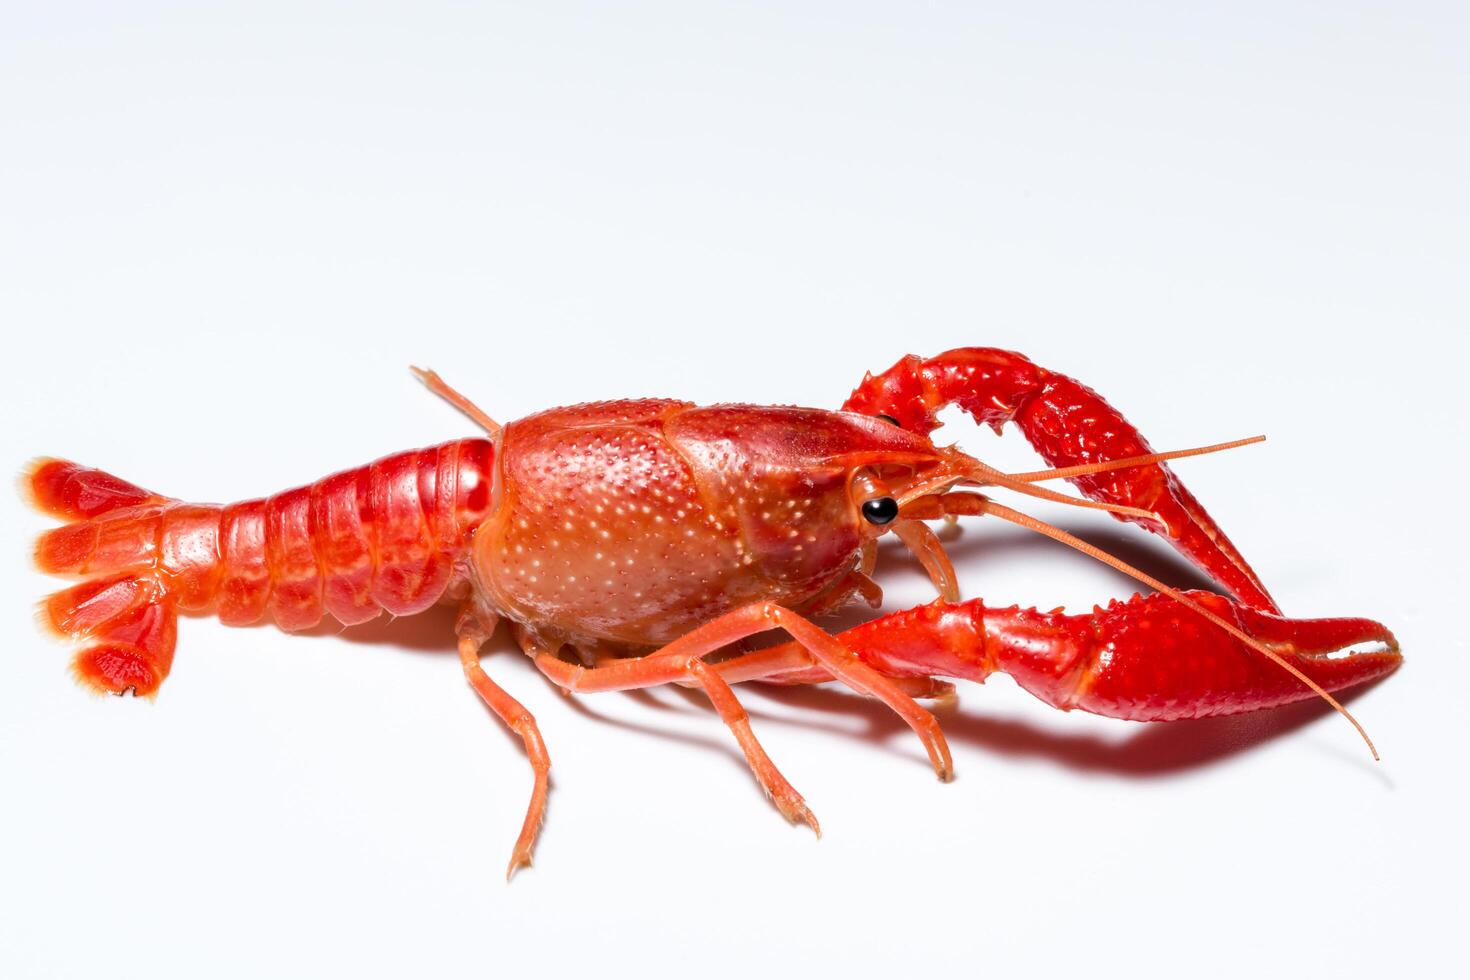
(22, 439, 494, 696)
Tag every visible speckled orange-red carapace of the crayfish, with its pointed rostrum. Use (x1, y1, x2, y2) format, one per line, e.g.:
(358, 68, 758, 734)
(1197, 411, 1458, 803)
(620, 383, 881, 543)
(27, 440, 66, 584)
(475, 401, 933, 646)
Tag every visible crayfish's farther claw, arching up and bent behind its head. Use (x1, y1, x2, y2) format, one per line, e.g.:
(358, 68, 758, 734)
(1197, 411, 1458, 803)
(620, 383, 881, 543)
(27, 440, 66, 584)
(842, 347, 1280, 613)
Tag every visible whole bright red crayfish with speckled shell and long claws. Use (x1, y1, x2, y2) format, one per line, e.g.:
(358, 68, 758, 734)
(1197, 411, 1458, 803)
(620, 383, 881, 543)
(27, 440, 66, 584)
(25, 348, 1401, 876)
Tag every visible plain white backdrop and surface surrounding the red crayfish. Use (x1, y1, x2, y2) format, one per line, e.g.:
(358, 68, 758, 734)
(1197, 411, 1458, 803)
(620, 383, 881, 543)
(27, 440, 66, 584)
(0, 0, 1470, 979)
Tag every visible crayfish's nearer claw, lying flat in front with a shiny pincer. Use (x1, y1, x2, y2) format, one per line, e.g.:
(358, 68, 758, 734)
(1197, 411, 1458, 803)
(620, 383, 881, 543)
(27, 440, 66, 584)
(841, 592, 1402, 721)
